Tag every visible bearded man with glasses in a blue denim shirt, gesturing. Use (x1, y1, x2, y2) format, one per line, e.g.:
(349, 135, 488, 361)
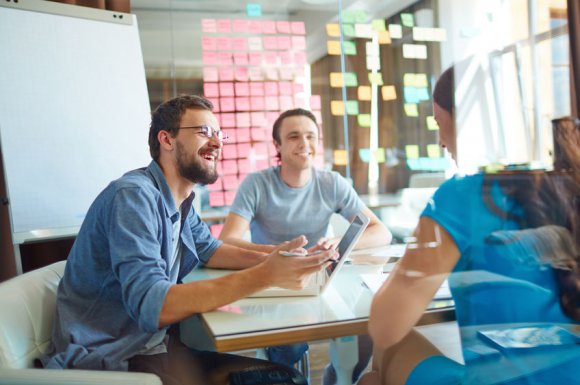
(43, 96, 336, 385)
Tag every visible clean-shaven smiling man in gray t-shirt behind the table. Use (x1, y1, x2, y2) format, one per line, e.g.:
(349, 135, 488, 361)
(220, 109, 391, 384)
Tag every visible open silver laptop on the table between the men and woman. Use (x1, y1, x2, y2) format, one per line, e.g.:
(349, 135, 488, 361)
(195, 213, 370, 297)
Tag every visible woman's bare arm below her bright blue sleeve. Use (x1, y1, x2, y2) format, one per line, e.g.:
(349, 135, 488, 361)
(369, 216, 460, 349)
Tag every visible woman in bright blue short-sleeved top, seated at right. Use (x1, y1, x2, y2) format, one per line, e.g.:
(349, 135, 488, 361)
(359, 68, 580, 385)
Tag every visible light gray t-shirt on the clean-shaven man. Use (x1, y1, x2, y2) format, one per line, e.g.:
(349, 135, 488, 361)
(230, 167, 364, 247)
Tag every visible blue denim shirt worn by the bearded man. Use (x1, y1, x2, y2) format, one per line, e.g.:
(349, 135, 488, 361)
(43, 161, 221, 370)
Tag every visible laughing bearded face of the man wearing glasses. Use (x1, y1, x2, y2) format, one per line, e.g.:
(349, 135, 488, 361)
(175, 109, 222, 184)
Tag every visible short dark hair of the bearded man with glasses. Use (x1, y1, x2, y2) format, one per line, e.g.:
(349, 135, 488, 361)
(149, 95, 213, 160)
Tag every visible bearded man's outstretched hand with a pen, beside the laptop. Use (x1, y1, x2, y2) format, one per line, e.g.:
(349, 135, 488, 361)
(263, 236, 338, 290)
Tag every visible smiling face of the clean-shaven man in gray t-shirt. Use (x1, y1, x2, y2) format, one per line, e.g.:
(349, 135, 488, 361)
(274, 116, 318, 170)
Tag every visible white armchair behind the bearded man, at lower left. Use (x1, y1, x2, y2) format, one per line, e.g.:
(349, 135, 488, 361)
(0, 261, 161, 385)
